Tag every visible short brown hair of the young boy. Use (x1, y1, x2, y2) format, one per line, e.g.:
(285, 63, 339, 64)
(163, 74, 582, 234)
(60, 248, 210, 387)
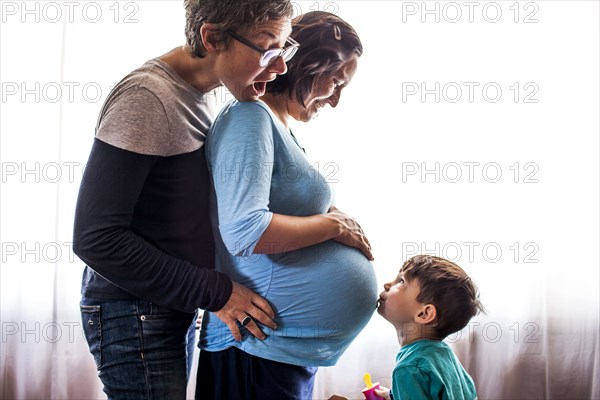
(400, 255, 483, 340)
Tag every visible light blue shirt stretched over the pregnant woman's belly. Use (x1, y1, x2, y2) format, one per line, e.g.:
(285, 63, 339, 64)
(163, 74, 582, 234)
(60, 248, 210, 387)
(200, 101, 377, 366)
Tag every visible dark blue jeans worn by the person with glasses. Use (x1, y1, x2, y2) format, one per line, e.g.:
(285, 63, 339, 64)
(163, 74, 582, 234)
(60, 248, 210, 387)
(81, 297, 196, 400)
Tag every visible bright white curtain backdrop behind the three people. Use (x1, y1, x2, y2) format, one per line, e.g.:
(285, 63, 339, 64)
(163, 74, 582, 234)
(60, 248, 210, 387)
(0, 0, 600, 399)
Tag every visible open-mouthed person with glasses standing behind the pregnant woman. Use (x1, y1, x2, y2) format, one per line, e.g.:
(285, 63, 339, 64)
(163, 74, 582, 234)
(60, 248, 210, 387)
(73, 0, 294, 399)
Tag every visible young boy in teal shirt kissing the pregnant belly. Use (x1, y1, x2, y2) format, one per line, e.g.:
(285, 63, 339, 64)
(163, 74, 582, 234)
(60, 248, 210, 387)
(376, 255, 483, 400)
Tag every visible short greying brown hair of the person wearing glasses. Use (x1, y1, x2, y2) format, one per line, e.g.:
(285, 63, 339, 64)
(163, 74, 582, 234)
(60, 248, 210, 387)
(184, 0, 293, 58)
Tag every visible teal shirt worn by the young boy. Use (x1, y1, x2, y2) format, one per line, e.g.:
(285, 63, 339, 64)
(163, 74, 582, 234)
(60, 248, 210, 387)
(392, 339, 477, 400)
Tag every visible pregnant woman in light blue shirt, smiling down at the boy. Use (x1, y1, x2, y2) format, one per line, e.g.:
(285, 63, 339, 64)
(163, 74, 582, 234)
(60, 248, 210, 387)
(196, 12, 377, 399)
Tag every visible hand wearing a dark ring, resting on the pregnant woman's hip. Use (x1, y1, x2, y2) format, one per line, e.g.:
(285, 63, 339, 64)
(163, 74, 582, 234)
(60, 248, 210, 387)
(214, 282, 277, 342)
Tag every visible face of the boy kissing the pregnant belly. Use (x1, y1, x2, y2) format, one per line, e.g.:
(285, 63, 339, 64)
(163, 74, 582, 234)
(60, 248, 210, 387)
(377, 271, 424, 327)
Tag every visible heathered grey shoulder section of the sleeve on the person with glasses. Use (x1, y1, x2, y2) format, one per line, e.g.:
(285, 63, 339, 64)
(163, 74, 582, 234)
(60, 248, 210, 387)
(96, 87, 172, 156)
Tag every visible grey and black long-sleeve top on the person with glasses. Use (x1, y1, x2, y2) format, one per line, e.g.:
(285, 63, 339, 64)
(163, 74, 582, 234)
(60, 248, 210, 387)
(73, 60, 232, 312)
